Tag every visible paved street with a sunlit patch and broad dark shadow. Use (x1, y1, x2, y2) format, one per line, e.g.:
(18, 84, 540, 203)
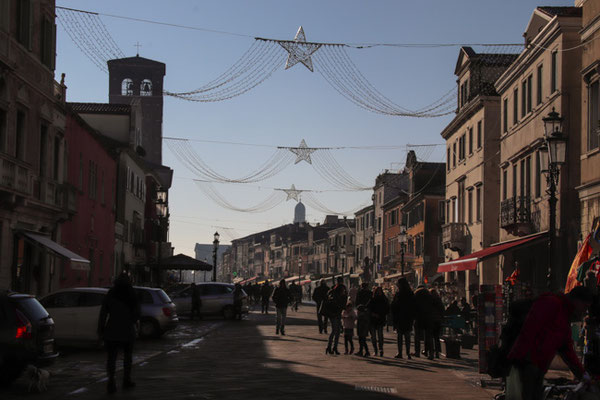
(2, 306, 506, 400)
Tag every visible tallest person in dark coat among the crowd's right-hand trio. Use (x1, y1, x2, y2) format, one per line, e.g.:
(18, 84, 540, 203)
(391, 278, 415, 360)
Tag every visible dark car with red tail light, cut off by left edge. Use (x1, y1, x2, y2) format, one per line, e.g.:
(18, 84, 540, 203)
(0, 292, 58, 386)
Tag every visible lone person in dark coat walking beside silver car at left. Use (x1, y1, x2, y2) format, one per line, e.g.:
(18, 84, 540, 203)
(98, 273, 140, 393)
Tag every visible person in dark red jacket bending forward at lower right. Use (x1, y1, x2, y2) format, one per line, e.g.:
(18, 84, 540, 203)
(506, 287, 592, 400)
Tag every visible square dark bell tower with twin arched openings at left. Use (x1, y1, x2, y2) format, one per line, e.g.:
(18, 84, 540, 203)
(108, 55, 166, 165)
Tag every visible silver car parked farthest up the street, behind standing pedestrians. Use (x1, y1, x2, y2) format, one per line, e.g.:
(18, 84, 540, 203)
(172, 282, 248, 319)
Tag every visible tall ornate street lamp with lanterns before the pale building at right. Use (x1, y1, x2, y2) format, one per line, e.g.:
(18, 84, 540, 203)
(542, 107, 567, 291)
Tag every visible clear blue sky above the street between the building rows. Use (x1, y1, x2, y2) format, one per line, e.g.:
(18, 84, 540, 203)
(55, 0, 574, 256)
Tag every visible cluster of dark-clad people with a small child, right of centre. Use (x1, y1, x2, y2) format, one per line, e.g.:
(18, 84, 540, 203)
(313, 278, 452, 359)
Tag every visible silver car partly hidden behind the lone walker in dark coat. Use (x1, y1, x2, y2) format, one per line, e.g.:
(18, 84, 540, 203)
(41, 286, 179, 346)
